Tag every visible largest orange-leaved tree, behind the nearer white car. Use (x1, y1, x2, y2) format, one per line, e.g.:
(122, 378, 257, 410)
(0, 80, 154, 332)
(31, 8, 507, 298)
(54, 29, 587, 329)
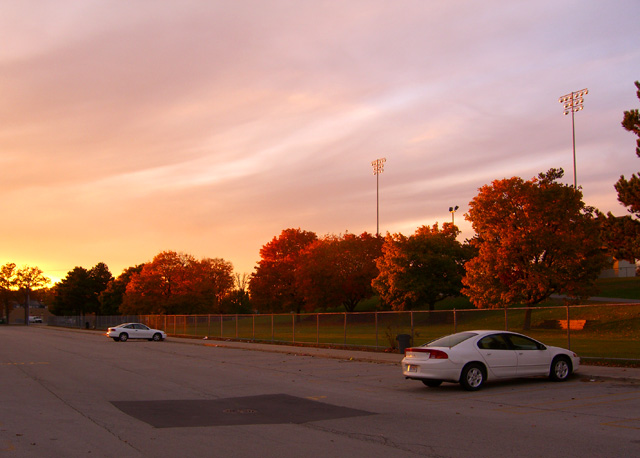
(462, 169, 607, 329)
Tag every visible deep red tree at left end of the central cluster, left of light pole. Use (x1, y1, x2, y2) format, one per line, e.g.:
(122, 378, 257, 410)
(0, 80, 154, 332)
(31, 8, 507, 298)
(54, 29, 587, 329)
(249, 228, 318, 313)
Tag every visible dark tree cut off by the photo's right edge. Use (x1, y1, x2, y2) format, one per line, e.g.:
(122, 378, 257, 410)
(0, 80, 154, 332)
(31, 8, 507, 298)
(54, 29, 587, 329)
(601, 81, 640, 263)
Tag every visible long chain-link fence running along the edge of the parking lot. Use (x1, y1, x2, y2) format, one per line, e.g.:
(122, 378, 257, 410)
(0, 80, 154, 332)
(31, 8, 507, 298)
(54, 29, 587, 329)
(48, 303, 640, 361)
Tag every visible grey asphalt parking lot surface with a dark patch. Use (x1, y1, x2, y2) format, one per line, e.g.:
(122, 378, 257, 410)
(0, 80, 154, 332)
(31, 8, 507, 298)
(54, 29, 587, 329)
(0, 326, 640, 458)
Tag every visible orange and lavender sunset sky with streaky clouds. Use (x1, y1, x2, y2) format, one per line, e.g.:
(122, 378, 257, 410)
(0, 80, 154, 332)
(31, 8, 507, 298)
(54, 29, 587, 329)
(0, 0, 640, 281)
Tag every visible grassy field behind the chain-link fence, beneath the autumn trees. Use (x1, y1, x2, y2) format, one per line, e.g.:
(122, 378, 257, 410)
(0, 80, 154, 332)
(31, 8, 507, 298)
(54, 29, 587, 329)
(136, 277, 640, 365)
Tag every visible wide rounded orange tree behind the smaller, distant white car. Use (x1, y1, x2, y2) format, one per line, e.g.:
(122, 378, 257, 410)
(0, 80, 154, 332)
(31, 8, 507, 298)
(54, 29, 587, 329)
(120, 251, 233, 315)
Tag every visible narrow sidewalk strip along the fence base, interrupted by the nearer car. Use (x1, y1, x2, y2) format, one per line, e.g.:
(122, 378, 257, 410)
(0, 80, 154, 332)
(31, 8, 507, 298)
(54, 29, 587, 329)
(169, 337, 640, 383)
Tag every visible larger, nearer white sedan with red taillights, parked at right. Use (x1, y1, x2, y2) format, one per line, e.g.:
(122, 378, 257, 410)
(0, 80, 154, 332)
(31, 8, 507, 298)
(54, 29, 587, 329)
(402, 331, 580, 391)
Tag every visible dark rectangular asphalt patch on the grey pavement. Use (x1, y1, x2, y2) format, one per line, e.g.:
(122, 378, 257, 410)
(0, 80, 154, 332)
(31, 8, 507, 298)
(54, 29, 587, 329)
(111, 394, 373, 428)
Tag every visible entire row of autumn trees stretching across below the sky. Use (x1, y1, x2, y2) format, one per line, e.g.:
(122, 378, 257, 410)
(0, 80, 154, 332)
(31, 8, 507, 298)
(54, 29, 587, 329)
(0, 82, 640, 326)
